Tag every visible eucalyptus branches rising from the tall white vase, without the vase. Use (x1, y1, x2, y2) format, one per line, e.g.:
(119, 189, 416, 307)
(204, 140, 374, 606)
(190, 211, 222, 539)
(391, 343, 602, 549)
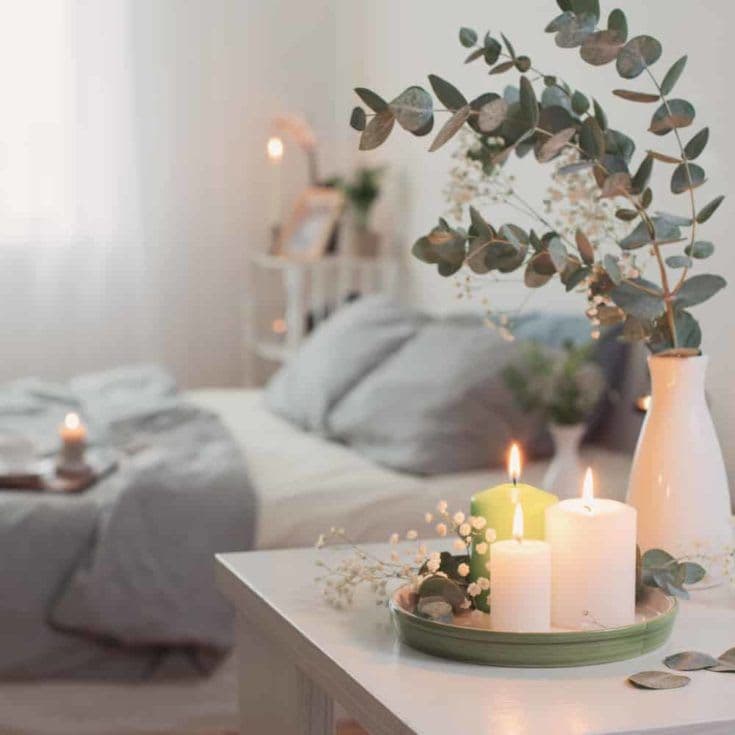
(350, 0, 724, 352)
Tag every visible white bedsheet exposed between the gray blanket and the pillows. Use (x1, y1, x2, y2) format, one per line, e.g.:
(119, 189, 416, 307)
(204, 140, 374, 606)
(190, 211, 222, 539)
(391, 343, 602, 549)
(187, 389, 630, 549)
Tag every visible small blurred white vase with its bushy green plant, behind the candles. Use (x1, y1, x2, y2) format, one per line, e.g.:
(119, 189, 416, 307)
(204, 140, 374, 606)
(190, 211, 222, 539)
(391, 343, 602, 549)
(503, 342, 605, 498)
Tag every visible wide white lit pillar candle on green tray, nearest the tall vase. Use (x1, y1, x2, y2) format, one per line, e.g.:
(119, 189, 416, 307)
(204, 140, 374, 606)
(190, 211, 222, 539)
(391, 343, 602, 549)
(546, 468, 636, 629)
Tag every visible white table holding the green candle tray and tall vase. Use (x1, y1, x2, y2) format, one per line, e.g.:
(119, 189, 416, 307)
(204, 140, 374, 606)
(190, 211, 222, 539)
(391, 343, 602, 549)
(217, 546, 735, 735)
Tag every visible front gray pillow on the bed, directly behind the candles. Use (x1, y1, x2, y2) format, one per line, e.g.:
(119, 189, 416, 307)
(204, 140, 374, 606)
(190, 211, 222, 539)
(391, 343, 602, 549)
(329, 318, 540, 474)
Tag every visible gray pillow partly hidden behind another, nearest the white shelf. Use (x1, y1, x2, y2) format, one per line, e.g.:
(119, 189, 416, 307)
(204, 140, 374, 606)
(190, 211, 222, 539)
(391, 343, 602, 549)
(265, 296, 426, 433)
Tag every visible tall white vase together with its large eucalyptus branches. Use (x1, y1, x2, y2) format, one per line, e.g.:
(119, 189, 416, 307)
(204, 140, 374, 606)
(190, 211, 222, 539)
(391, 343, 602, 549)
(351, 0, 732, 568)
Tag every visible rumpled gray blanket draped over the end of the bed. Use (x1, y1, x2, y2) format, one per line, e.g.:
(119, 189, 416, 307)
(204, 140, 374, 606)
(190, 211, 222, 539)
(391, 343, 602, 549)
(0, 367, 255, 678)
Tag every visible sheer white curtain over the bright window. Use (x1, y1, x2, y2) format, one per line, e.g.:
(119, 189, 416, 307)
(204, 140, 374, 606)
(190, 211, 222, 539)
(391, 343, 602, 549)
(0, 0, 243, 385)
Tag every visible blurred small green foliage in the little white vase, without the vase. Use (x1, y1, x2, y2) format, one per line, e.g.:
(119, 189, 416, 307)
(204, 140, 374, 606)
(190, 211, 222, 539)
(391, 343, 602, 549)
(503, 342, 605, 425)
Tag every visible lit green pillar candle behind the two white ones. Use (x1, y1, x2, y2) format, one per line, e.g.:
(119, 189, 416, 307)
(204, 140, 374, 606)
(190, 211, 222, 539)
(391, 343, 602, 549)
(470, 444, 559, 612)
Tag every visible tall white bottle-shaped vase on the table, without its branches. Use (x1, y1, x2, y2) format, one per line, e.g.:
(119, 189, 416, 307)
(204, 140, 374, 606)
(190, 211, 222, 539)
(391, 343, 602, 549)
(628, 355, 733, 564)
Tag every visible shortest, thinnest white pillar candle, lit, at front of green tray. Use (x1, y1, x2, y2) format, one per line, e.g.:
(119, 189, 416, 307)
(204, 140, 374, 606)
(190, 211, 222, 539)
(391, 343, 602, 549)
(490, 503, 551, 633)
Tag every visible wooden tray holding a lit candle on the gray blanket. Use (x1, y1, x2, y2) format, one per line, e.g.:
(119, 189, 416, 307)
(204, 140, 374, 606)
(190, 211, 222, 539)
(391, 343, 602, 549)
(0, 451, 118, 493)
